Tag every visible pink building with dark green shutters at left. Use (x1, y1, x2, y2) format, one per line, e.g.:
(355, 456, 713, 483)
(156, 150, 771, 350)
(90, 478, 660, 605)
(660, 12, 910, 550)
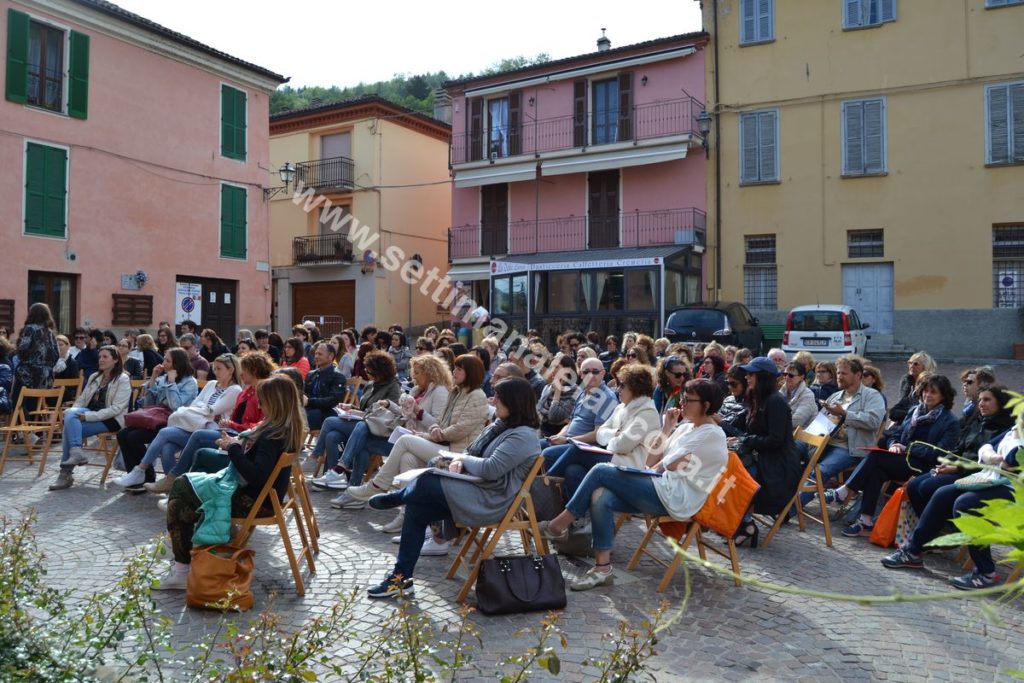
(0, 0, 286, 340)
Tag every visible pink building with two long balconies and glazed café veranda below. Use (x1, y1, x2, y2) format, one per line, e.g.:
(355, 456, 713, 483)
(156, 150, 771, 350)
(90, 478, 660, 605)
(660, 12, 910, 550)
(445, 33, 708, 339)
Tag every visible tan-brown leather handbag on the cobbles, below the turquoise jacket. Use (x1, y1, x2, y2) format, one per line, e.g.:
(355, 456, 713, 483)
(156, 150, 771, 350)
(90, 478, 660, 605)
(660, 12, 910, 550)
(185, 546, 256, 611)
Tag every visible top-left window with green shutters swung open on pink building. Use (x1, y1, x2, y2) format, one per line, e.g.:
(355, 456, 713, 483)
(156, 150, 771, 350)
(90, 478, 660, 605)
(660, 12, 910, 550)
(5, 9, 89, 119)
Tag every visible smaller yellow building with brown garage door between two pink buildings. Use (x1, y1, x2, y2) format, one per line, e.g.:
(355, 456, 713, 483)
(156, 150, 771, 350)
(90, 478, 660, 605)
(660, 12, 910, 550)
(270, 96, 452, 332)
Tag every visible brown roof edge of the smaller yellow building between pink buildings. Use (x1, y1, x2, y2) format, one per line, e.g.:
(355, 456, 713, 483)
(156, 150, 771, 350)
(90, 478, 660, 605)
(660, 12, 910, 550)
(270, 95, 452, 142)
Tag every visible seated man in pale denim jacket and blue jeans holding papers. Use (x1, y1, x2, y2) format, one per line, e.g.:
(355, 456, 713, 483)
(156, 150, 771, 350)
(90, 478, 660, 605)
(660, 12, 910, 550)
(800, 355, 886, 515)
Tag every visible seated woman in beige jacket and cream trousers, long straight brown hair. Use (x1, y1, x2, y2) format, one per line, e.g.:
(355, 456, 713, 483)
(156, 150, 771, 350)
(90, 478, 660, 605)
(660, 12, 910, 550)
(331, 353, 489, 510)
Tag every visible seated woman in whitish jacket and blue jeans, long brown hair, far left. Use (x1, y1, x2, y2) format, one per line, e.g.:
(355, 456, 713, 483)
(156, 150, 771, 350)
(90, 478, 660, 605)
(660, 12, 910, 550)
(50, 346, 131, 490)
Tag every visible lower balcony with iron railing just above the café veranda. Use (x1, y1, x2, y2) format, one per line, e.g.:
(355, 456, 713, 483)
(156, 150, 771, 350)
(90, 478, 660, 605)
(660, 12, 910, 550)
(449, 207, 708, 261)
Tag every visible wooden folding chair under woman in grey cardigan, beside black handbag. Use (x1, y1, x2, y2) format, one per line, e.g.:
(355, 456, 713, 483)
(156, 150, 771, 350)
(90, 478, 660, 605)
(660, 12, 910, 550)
(446, 456, 548, 602)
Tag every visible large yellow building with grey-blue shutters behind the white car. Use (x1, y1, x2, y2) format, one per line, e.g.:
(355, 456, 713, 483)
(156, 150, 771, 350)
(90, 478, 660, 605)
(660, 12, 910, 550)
(701, 0, 1024, 357)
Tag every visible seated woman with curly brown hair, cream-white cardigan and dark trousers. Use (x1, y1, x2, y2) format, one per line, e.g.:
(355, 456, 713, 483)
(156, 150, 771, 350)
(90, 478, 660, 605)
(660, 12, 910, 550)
(545, 364, 662, 499)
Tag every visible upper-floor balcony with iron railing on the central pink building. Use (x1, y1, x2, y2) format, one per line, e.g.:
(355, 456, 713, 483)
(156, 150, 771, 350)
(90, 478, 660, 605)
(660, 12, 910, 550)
(451, 96, 705, 165)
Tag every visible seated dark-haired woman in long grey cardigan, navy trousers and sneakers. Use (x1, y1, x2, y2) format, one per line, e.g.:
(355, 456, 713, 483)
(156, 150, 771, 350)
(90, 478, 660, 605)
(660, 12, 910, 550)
(367, 378, 541, 598)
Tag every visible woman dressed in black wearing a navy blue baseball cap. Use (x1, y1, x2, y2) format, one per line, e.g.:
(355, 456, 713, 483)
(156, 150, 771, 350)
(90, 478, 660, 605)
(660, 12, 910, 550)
(730, 355, 801, 548)
